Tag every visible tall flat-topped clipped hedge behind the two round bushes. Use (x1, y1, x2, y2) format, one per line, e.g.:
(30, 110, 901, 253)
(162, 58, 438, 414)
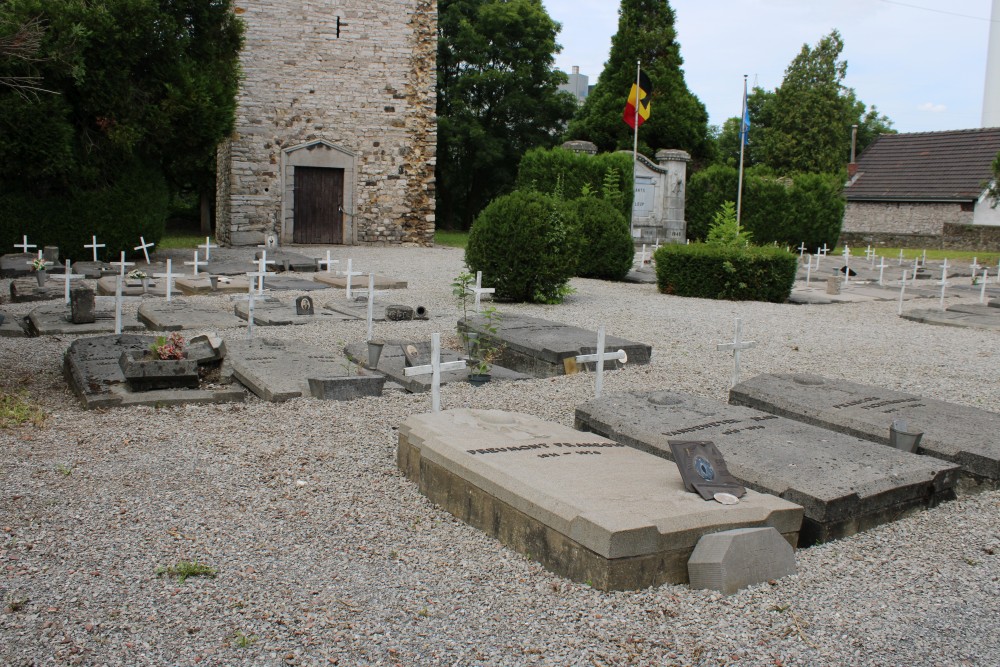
(515, 148, 632, 218)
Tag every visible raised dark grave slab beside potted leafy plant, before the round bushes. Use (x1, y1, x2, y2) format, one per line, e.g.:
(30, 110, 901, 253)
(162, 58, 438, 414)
(458, 314, 653, 377)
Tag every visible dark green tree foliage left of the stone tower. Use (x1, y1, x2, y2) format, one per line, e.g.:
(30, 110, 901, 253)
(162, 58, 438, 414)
(0, 0, 243, 253)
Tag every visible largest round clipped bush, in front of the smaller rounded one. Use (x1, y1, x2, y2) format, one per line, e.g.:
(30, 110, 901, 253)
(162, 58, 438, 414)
(465, 191, 579, 303)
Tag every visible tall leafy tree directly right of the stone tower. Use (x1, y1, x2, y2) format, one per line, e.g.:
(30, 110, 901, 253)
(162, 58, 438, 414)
(436, 0, 576, 229)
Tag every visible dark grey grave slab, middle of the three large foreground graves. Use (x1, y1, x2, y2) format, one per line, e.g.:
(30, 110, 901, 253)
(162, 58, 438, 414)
(576, 391, 959, 544)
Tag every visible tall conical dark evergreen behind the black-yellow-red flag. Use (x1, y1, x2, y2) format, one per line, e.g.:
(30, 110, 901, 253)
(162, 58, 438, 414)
(566, 0, 713, 161)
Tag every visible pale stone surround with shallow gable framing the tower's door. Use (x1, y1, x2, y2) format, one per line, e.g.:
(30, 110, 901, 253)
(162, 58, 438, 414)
(281, 139, 357, 245)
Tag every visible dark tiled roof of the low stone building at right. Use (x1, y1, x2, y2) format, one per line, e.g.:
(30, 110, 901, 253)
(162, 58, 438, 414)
(845, 127, 1000, 201)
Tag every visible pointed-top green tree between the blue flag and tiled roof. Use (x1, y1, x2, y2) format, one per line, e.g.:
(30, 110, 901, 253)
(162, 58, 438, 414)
(747, 30, 892, 173)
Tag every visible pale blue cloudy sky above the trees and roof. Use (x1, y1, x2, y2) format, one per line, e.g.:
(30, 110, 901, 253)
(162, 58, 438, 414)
(542, 0, 1000, 132)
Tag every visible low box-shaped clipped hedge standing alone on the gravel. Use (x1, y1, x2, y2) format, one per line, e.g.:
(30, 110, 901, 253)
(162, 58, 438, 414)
(654, 243, 798, 303)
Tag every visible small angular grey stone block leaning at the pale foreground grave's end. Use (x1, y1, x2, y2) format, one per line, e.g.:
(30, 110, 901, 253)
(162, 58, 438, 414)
(688, 526, 798, 595)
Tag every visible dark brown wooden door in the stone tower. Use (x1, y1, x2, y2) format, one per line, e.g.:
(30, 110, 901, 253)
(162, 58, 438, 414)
(292, 167, 344, 245)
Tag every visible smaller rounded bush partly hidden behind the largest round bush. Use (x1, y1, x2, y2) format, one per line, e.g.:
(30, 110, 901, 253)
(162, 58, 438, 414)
(563, 197, 635, 280)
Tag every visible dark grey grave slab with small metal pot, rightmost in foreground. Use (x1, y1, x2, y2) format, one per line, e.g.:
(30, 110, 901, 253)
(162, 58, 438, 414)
(729, 373, 1000, 486)
